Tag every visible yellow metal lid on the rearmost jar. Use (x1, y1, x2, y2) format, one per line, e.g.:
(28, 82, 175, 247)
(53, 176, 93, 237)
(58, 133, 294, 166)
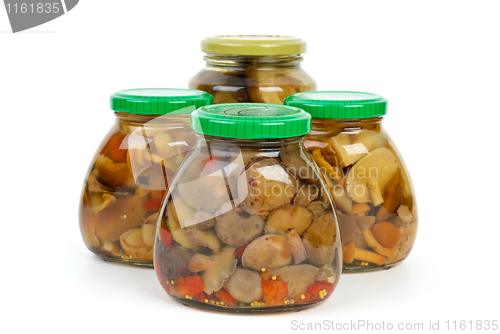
(201, 35, 306, 56)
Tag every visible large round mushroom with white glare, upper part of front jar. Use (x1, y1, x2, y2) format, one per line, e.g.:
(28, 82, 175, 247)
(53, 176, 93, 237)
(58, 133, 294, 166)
(238, 158, 297, 218)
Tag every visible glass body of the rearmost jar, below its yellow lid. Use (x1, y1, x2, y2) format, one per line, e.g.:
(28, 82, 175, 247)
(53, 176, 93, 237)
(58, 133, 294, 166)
(189, 54, 316, 104)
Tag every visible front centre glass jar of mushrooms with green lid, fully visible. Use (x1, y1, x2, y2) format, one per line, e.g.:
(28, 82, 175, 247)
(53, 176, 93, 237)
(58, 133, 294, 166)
(155, 103, 342, 313)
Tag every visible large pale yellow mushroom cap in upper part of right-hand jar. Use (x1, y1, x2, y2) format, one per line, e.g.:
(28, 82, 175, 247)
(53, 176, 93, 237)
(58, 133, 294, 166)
(346, 147, 399, 203)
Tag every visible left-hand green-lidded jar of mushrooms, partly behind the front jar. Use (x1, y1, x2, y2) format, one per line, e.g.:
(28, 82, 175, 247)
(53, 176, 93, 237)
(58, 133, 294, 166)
(79, 89, 213, 266)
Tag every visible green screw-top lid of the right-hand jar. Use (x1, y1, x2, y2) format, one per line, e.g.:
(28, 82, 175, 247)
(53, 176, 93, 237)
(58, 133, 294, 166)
(284, 92, 387, 119)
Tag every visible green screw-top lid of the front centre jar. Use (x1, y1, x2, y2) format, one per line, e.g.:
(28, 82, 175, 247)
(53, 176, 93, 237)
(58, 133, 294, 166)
(191, 103, 311, 139)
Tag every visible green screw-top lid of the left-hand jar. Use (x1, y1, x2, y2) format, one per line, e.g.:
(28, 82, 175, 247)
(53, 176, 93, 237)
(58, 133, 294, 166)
(111, 88, 214, 115)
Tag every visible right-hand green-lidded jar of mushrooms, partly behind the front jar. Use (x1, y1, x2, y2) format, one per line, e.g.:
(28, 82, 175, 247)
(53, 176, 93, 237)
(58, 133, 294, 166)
(285, 92, 418, 272)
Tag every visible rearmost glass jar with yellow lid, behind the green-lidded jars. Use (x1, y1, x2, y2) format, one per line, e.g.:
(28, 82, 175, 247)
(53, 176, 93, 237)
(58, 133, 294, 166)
(189, 35, 316, 104)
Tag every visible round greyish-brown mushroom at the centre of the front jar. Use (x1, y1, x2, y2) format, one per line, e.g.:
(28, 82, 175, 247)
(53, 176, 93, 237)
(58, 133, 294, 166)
(215, 201, 265, 247)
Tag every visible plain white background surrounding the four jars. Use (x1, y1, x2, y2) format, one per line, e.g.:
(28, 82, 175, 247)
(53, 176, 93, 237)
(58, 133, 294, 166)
(0, 0, 500, 333)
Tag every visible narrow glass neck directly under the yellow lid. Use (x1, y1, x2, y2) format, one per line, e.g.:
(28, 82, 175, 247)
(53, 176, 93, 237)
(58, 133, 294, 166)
(203, 53, 303, 67)
